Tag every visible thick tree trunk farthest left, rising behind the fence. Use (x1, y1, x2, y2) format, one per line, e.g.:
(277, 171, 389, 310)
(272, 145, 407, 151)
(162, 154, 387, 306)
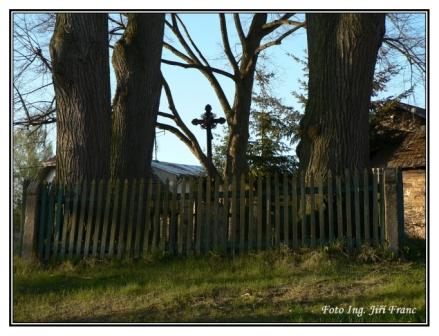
(50, 13, 111, 184)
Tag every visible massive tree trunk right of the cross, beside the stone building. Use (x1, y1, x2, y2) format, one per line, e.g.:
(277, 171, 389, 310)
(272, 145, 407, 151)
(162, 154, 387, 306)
(297, 14, 385, 179)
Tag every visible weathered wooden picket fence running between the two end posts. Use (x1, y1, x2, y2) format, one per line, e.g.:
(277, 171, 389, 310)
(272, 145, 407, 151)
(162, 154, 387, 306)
(31, 169, 402, 260)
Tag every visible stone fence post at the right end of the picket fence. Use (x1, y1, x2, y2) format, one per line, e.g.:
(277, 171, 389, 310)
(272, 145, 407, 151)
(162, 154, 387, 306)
(384, 169, 404, 253)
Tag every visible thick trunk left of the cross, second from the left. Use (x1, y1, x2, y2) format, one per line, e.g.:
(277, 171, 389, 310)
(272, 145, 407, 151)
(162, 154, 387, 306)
(111, 14, 165, 178)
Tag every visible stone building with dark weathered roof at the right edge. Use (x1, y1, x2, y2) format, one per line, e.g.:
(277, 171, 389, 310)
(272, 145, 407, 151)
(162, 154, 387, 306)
(371, 103, 426, 238)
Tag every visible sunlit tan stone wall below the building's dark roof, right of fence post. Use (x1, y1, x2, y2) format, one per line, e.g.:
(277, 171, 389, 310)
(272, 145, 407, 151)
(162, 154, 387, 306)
(402, 169, 426, 239)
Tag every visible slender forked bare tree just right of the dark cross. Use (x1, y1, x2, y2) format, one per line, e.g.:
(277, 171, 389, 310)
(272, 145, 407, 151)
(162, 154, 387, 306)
(158, 13, 305, 176)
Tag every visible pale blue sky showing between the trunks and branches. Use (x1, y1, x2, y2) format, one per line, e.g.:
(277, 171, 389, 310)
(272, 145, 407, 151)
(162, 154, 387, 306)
(12, 13, 425, 165)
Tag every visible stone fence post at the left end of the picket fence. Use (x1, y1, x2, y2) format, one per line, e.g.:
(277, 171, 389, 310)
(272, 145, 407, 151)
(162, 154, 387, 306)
(21, 181, 40, 260)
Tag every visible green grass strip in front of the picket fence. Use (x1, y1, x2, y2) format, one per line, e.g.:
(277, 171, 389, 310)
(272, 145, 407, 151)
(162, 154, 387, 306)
(13, 240, 426, 323)
